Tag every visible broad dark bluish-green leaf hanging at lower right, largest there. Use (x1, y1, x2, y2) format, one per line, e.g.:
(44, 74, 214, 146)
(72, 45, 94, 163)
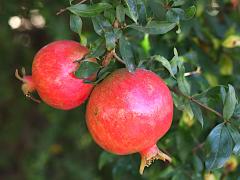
(205, 123, 233, 170)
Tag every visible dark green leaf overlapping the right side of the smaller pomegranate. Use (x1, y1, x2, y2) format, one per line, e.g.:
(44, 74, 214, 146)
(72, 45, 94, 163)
(75, 61, 101, 79)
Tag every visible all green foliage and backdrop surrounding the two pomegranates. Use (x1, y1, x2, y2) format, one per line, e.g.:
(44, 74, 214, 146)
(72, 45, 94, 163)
(0, 0, 240, 179)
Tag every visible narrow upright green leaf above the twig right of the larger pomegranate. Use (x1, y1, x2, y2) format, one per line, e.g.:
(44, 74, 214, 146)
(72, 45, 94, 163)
(177, 65, 190, 95)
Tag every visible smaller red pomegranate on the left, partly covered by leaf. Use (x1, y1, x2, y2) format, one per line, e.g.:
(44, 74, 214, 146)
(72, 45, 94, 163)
(16, 40, 93, 110)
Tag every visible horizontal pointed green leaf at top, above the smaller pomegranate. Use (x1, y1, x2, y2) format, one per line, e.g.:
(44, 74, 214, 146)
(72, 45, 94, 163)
(67, 3, 112, 17)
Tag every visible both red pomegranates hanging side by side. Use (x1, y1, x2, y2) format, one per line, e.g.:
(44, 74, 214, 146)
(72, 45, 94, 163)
(17, 41, 173, 174)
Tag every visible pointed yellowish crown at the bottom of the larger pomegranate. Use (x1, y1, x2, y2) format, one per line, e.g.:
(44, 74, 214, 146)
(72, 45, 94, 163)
(139, 144, 172, 175)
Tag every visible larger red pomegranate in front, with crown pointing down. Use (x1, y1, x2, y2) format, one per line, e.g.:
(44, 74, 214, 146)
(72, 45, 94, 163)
(86, 69, 173, 174)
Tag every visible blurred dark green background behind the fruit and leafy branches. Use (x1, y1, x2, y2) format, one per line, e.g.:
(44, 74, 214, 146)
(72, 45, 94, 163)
(0, 0, 240, 180)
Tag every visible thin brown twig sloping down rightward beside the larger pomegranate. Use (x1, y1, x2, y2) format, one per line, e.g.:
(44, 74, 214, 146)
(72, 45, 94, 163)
(172, 88, 224, 120)
